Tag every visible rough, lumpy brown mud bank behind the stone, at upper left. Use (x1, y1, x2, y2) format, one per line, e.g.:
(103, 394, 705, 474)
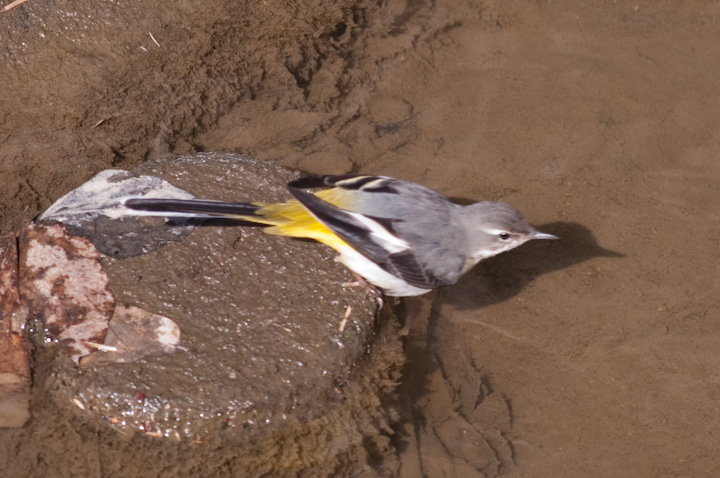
(0, 1, 394, 231)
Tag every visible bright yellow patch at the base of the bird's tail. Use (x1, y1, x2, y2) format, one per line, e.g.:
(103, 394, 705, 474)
(252, 196, 348, 252)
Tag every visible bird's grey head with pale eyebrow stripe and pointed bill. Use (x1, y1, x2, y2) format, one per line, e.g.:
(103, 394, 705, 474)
(459, 201, 558, 270)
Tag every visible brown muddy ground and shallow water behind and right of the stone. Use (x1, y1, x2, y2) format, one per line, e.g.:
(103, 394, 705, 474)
(0, 0, 720, 478)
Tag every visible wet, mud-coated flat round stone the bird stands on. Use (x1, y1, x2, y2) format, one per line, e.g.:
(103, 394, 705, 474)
(38, 154, 403, 476)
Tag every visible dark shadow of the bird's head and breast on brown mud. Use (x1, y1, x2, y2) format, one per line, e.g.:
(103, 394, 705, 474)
(437, 222, 625, 310)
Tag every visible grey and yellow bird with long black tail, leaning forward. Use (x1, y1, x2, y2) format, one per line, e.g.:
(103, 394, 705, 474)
(123, 174, 558, 297)
